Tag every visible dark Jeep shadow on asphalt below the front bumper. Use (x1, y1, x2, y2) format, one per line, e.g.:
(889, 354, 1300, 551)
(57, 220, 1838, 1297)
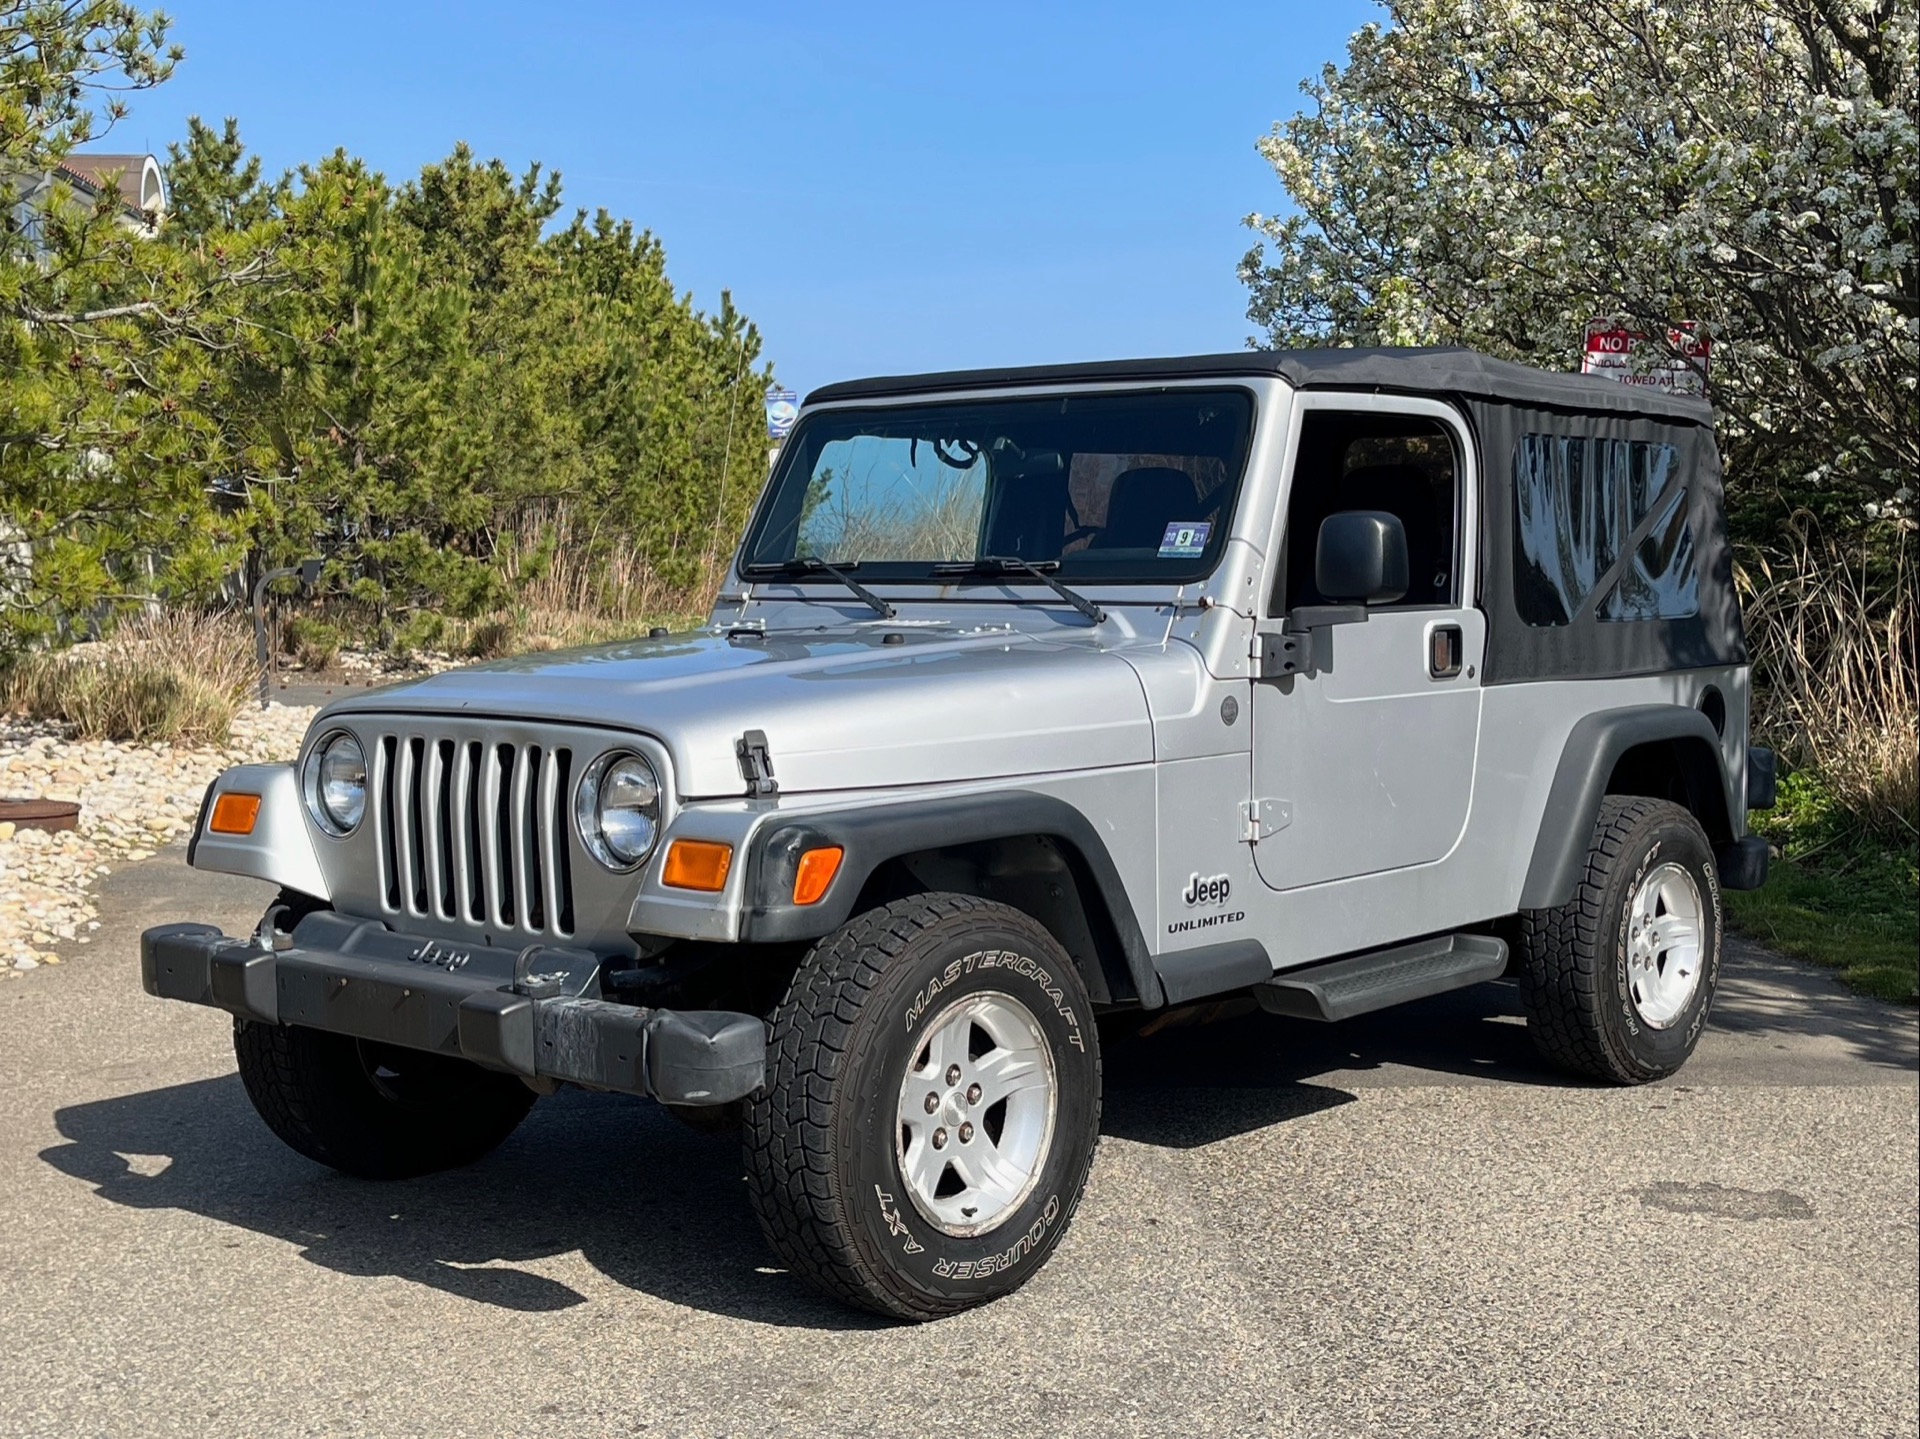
(40, 1074, 883, 1329)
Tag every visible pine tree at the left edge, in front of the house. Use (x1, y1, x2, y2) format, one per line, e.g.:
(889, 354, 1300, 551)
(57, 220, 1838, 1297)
(0, 0, 257, 649)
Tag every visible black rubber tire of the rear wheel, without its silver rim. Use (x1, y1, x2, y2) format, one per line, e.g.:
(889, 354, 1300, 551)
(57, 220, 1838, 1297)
(1519, 795, 1722, 1084)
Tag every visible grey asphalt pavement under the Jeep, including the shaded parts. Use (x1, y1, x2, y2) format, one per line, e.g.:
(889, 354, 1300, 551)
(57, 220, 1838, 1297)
(0, 851, 1920, 1439)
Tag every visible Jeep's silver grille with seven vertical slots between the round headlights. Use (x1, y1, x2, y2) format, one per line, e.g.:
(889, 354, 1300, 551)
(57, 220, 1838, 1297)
(369, 734, 574, 938)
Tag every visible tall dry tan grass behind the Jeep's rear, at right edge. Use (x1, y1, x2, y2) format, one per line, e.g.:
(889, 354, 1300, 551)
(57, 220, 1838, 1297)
(1736, 515, 1920, 843)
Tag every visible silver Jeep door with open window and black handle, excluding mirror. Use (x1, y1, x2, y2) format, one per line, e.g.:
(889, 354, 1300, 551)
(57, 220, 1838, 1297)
(1252, 394, 1486, 890)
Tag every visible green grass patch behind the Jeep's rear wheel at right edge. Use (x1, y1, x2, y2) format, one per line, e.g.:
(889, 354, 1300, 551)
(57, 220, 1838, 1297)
(1726, 770, 1920, 1005)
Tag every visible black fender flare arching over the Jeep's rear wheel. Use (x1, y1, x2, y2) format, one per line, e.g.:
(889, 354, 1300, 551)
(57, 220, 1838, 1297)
(1519, 705, 1736, 909)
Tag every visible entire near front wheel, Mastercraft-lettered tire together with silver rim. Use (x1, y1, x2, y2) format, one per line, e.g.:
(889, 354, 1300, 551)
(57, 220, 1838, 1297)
(745, 895, 1100, 1320)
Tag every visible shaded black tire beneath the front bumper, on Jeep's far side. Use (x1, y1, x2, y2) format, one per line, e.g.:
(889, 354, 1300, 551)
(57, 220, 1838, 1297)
(234, 1020, 538, 1180)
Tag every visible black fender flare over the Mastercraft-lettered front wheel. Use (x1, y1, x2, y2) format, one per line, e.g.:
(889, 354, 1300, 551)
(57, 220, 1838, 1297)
(739, 790, 1164, 1009)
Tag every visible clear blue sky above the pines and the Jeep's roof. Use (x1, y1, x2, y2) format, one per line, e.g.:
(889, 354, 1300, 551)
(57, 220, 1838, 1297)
(123, 0, 1380, 390)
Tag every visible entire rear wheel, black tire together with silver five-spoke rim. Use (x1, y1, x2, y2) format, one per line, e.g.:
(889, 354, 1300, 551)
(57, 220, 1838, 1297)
(1521, 795, 1720, 1084)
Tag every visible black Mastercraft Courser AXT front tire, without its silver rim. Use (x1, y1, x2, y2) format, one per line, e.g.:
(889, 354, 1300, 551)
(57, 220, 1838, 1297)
(745, 893, 1100, 1320)
